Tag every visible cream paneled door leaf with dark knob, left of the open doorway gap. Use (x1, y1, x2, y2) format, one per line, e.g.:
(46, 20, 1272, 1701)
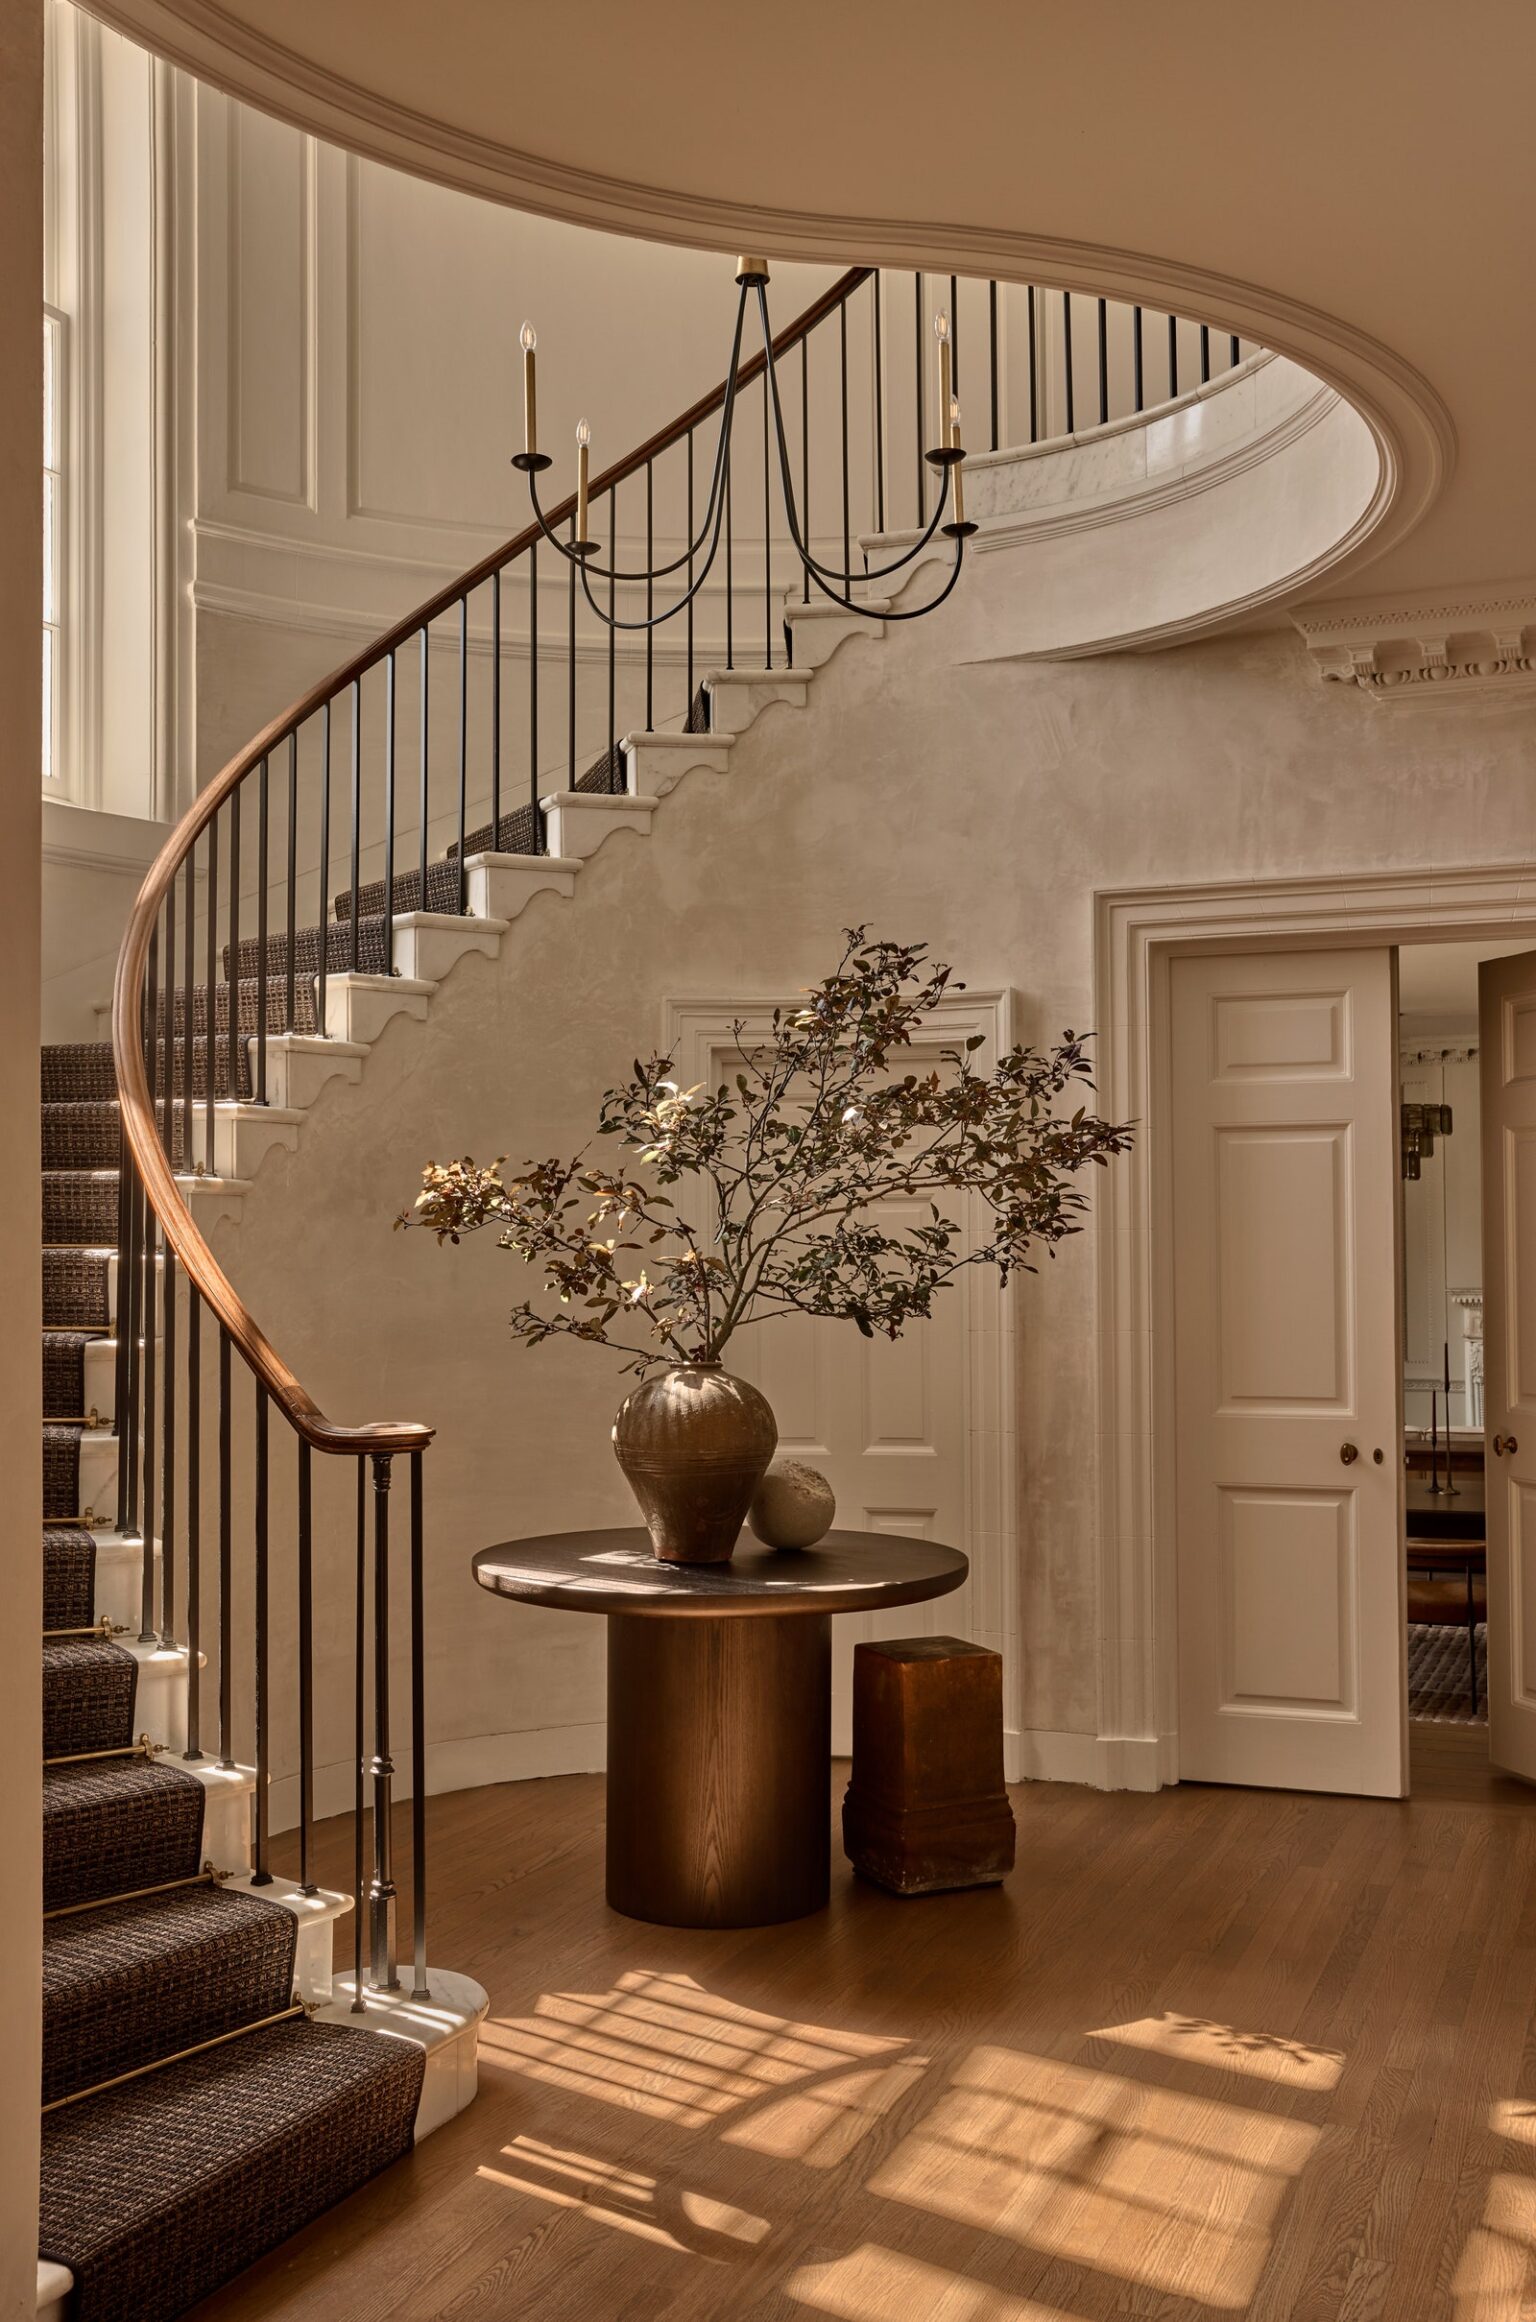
(1171, 950, 1403, 1797)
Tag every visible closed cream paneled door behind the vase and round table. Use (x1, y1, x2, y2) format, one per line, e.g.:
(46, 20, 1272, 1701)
(725, 1200, 971, 1755)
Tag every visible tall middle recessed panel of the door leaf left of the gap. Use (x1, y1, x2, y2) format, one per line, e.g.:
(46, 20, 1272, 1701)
(1215, 1126, 1350, 1407)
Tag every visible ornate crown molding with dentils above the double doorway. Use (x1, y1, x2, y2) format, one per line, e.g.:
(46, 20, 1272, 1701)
(1292, 581, 1536, 704)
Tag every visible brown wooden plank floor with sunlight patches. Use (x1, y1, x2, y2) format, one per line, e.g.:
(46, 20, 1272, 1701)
(198, 1728, 1536, 2322)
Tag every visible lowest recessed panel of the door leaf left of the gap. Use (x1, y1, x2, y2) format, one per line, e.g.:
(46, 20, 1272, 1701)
(1218, 1491, 1357, 1711)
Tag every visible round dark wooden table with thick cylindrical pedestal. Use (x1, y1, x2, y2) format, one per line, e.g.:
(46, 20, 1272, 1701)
(474, 1526, 969, 1927)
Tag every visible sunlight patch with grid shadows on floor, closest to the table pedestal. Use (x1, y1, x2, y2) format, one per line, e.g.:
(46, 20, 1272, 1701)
(481, 1969, 906, 2150)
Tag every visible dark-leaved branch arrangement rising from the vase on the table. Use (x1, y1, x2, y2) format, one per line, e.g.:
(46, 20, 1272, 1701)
(395, 926, 1132, 1372)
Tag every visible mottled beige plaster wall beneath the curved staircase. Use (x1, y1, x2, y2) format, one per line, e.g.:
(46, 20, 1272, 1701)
(197, 603, 1536, 1786)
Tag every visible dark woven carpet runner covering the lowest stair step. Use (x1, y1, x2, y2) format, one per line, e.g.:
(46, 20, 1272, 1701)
(40, 2018, 425, 2322)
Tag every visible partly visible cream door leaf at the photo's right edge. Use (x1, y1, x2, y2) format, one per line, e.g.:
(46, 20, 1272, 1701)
(1478, 952, 1536, 1781)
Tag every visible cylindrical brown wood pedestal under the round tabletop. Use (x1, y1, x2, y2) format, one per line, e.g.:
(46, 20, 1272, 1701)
(609, 1611, 832, 1927)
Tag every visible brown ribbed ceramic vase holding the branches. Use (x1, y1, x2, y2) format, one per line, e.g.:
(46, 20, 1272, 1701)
(613, 1363, 778, 1565)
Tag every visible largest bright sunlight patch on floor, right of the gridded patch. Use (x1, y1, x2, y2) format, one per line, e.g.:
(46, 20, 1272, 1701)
(867, 2048, 1318, 2308)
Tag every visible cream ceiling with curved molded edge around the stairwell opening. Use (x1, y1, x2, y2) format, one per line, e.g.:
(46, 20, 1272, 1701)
(88, 0, 1536, 594)
